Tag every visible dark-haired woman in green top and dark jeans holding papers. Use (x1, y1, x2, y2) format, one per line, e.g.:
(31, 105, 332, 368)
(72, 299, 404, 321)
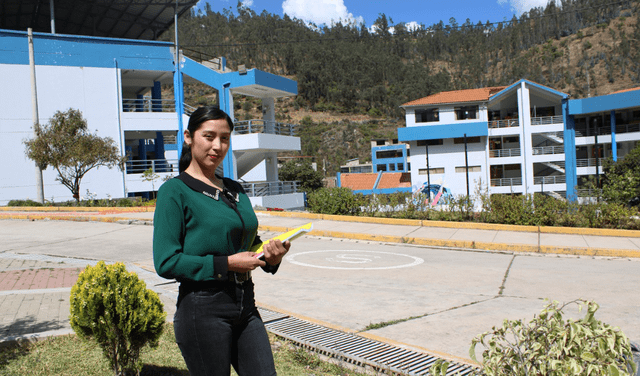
(153, 107, 290, 376)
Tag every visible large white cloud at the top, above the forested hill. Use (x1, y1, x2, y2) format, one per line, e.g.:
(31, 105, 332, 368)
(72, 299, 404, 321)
(282, 0, 364, 26)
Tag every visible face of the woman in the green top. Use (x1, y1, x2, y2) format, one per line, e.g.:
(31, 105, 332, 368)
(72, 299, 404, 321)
(184, 119, 231, 173)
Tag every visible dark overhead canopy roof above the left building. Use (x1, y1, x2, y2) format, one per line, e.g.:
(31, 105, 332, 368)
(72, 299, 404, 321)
(0, 0, 198, 40)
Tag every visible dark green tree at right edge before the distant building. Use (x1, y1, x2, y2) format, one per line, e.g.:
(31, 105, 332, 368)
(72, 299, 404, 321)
(602, 145, 640, 206)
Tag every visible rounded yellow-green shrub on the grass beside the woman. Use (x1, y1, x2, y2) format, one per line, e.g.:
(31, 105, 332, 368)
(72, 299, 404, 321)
(70, 261, 166, 375)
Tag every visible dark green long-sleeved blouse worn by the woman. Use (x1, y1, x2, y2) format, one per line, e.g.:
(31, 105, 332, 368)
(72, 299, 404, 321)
(153, 178, 258, 281)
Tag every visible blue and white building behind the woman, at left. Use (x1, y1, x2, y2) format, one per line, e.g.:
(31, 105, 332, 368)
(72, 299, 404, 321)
(0, 0, 304, 209)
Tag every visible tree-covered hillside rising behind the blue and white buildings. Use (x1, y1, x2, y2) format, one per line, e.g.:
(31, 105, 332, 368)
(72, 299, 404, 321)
(167, 0, 640, 175)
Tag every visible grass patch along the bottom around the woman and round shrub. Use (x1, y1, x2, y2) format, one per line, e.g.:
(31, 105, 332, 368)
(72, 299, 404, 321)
(0, 324, 363, 376)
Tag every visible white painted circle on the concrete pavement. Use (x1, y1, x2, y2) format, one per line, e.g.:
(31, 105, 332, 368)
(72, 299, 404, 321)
(286, 249, 424, 270)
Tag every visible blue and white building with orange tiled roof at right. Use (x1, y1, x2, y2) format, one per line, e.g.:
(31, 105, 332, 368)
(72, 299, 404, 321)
(398, 79, 640, 199)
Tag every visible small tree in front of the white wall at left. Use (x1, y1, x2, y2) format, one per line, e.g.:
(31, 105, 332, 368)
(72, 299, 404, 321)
(24, 108, 126, 201)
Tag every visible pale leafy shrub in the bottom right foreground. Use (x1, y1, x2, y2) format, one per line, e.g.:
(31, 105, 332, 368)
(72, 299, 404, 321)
(431, 300, 636, 376)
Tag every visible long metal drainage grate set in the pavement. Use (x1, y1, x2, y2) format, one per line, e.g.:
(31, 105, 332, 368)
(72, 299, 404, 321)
(260, 308, 478, 376)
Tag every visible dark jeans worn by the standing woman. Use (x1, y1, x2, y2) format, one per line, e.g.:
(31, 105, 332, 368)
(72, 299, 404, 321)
(173, 280, 276, 376)
